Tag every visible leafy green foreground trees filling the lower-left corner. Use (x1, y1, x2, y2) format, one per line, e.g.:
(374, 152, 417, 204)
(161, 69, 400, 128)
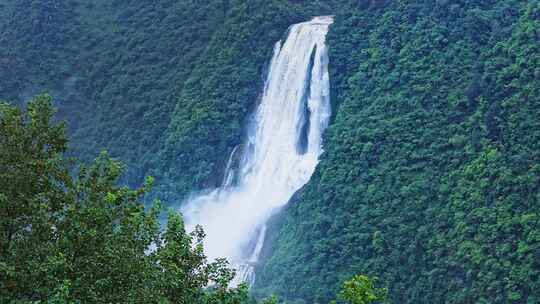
(0, 95, 247, 304)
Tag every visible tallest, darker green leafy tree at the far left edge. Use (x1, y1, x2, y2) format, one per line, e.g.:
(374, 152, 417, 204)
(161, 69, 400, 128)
(0, 95, 73, 302)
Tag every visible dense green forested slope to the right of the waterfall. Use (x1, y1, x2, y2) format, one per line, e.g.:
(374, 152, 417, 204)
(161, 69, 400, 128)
(258, 1, 540, 303)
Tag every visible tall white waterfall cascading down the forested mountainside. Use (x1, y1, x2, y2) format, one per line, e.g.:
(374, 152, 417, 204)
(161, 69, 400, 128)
(182, 17, 333, 284)
